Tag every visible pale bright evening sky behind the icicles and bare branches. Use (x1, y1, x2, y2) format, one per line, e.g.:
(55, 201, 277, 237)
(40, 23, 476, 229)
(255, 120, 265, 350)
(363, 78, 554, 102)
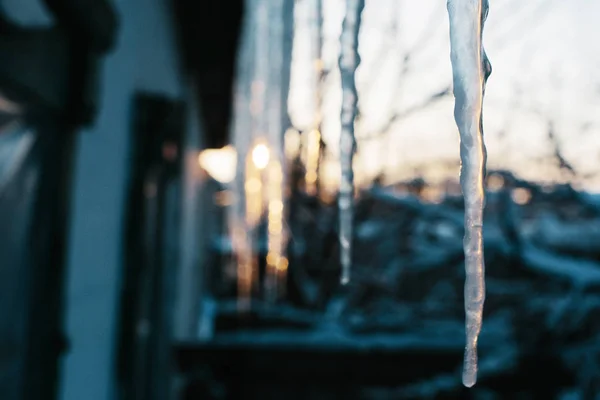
(289, 0, 600, 192)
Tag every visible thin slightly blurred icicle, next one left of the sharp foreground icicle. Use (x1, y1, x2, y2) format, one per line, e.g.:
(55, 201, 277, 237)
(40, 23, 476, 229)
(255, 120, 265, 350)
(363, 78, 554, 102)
(338, 0, 365, 284)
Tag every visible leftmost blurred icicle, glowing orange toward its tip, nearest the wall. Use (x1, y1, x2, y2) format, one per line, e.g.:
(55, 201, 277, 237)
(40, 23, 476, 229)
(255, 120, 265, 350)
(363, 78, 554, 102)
(228, 0, 272, 308)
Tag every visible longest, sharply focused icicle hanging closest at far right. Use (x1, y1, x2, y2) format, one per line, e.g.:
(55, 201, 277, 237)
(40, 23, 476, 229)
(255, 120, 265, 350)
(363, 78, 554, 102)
(448, 0, 491, 387)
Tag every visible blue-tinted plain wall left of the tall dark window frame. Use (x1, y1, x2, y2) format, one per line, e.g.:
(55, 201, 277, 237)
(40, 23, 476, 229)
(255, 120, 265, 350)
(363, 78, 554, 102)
(61, 0, 181, 400)
